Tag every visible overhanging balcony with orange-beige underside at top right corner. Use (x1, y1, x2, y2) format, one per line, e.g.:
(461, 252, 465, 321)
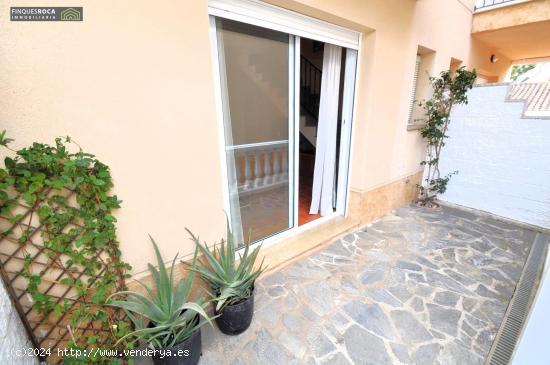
(472, 0, 550, 60)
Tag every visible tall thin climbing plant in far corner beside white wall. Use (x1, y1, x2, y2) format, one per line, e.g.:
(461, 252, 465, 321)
(418, 67, 477, 206)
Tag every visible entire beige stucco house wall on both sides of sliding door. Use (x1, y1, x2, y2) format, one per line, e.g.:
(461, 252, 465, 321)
(0, 0, 508, 272)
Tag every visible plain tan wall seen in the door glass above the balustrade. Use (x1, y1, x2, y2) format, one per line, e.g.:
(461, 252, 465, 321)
(220, 22, 289, 145)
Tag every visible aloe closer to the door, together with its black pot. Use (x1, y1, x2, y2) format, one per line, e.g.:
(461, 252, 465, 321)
(186, 222, 264, 335)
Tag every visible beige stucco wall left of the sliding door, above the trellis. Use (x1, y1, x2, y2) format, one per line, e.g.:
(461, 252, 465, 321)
(0, 0, 225, 271)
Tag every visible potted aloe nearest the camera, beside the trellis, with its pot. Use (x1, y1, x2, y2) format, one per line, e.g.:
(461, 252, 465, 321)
(109, 237, 211, 365)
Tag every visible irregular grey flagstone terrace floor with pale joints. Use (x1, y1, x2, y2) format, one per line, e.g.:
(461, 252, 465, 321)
(140, 206, 535, 365)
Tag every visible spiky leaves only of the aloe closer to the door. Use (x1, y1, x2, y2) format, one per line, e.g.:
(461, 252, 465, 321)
(186, 221, 264, 311)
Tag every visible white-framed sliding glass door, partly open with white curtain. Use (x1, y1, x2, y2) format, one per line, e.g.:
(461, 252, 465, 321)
(210, 16, 357, 245)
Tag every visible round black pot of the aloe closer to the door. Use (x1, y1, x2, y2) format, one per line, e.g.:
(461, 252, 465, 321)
(214, 288, 254, 336)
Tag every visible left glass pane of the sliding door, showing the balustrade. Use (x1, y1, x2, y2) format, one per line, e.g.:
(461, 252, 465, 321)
(216, 18, 290, 242)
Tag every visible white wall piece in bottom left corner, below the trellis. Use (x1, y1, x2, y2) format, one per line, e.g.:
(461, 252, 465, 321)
(0, 280, 38, 365)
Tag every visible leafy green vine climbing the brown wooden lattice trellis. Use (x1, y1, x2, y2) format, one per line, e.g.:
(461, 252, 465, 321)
(0, 131, 131, 363)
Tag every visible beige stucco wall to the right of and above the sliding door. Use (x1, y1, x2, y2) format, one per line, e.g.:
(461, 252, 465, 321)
(269, 0, 510, 192)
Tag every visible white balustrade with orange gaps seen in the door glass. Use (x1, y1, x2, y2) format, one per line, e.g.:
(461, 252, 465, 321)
(227, 140, 288, 195)
